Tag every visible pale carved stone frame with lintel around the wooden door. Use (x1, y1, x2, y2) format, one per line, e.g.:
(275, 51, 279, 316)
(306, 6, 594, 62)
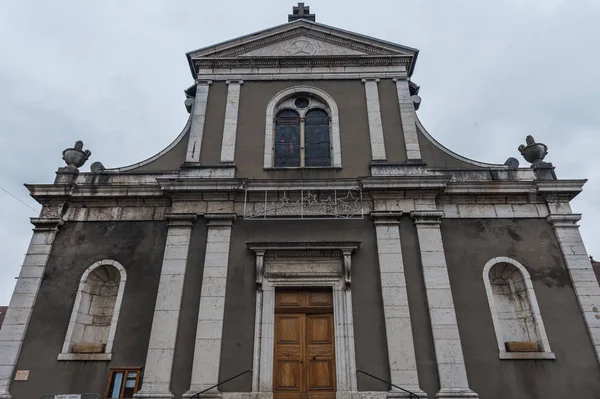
(248, 242, 359, 399)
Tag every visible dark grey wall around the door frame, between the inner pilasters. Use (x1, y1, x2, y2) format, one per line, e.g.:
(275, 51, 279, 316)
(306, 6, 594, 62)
(219, 219, 389, 392)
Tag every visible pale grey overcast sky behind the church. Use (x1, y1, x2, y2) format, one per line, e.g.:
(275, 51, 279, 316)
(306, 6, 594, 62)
(0, 0, 600, 305)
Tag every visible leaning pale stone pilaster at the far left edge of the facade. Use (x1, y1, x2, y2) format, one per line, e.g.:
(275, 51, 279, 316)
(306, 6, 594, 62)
(0, 218, 63, 399)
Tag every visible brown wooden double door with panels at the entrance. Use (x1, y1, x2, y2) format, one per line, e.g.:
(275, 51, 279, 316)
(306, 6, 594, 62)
(273, 290, 336, 399)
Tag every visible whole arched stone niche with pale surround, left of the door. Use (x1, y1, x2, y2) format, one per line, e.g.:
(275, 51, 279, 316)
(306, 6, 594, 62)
(58, 260, 127, 360)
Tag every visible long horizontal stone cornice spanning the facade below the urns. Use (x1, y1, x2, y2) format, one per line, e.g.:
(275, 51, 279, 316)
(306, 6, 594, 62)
(26, 178, 586, 204)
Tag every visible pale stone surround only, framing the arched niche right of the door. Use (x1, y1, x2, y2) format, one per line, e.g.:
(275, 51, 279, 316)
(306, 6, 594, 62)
(483, 256, 556, 360)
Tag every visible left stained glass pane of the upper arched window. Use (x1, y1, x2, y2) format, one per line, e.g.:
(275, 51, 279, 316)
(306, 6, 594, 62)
(275, 109, 300, 167)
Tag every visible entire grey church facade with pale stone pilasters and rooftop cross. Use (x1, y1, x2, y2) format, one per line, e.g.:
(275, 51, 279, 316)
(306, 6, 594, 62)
(0, 3, 600, 399)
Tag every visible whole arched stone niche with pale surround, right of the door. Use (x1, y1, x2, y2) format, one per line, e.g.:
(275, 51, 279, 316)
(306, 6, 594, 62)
(483, 257, 554, 359)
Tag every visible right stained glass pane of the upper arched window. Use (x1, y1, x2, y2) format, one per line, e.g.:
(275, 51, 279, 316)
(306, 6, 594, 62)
(304, 108, 331, 166)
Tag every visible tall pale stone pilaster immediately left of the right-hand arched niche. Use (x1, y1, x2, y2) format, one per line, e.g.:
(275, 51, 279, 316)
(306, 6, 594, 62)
(410, 211, 477, 398)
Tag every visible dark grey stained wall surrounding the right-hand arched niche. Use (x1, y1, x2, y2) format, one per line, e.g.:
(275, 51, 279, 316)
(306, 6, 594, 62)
(442, 219, 600, 399)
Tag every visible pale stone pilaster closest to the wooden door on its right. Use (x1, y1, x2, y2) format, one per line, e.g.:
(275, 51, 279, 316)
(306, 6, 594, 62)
(371, 212, 427, 397)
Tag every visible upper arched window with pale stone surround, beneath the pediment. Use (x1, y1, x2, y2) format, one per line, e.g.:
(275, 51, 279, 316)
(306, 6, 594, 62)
(265, 86, 342, 168)
